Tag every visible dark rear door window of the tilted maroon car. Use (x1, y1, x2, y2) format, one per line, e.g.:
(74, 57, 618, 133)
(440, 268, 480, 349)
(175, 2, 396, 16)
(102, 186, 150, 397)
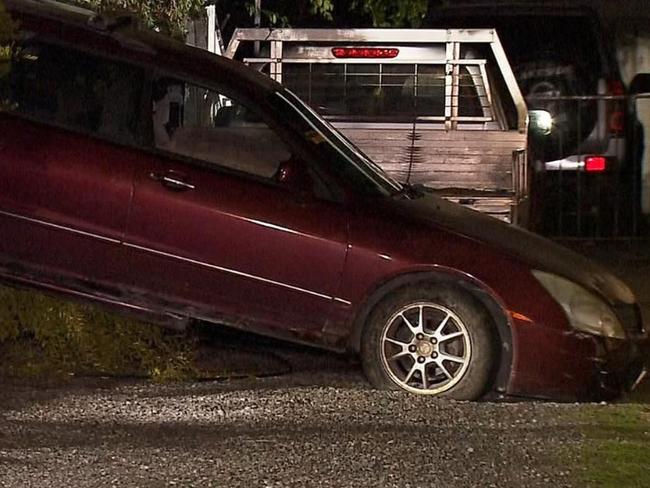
(0, 39, 142, 143)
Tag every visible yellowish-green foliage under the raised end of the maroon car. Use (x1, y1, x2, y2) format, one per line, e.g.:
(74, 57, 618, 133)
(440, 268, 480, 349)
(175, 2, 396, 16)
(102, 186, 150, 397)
(0, 287, 195, 381)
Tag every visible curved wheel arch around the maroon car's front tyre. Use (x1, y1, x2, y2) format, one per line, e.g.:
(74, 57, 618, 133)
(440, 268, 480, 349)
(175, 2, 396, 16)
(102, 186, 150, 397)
(347, 270, 513, 397)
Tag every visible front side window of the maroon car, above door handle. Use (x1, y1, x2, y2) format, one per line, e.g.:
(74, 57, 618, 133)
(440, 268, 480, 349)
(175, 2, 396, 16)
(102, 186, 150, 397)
(152, 78, 291, 179)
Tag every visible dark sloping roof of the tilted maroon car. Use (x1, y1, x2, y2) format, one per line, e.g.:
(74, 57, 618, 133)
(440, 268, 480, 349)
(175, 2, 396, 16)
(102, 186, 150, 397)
(5, 0, 280, 98)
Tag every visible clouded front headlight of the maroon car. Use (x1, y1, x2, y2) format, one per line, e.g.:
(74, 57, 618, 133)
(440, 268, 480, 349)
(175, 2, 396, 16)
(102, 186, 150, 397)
(532, 270, 625, 339)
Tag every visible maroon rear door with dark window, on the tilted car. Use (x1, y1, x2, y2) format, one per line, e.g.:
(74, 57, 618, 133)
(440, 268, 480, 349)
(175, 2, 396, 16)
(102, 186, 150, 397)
(0, 33, 142, 291)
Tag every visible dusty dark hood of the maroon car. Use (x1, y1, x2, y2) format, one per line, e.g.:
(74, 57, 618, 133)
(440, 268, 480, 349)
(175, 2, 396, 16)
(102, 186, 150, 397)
(399, 192, 635, 305)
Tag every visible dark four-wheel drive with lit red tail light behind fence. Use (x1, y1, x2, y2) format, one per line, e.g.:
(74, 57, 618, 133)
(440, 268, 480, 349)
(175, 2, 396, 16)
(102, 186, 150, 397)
(423, 0, 650, 238)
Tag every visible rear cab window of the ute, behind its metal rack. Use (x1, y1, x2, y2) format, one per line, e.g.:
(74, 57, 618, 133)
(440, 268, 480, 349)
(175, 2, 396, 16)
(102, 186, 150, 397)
(283, 60, 487, 122)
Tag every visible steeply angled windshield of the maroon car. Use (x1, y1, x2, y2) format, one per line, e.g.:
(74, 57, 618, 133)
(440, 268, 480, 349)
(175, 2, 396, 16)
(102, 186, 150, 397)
(270, 89, 403, 196)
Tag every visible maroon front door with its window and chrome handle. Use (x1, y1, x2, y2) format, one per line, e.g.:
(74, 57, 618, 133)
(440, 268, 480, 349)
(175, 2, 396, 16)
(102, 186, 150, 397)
(126, 78, 347, 338)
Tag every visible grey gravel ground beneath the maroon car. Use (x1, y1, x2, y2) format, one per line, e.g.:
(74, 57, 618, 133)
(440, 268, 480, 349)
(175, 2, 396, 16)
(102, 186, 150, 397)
(0, 368, 579, 488)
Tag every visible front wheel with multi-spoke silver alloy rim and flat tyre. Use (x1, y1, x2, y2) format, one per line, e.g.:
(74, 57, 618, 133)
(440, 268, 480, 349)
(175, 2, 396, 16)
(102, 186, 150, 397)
(361, 284, 497, 400)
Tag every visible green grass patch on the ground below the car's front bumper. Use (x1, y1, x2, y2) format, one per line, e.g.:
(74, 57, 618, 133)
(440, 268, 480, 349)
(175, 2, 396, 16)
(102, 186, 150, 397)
(579, 404, 650, 488)
